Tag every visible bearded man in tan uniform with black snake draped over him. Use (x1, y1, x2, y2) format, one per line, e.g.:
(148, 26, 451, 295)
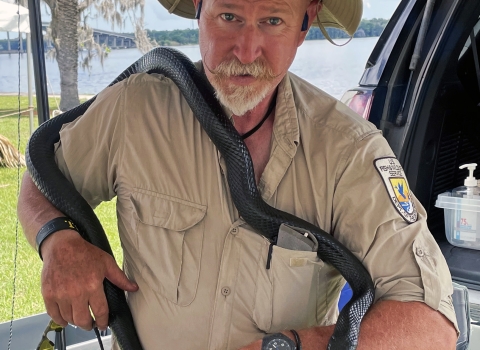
(19, 0, 456, 350)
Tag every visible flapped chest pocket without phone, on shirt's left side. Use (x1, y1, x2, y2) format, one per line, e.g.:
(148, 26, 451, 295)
(132, 189, 207, 306)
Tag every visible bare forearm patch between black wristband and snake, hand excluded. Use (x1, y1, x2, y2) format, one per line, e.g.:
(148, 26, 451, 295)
(17, 172, 63, 247)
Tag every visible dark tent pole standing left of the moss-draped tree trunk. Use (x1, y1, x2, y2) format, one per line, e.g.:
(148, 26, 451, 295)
(28, 0, 50, 125)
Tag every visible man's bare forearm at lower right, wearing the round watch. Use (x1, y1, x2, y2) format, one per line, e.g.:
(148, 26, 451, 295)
(294, 301, 457, 350)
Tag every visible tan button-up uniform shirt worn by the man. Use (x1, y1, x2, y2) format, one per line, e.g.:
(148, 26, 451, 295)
(57, 64, 456, 350)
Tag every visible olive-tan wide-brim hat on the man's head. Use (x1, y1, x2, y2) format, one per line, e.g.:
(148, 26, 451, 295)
(158, 0, 363, 36)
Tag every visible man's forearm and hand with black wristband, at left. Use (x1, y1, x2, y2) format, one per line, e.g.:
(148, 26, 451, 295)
(18, 174, 138, 330)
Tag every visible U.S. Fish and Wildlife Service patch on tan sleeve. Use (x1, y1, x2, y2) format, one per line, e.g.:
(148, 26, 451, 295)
(373, 157, 418, 224)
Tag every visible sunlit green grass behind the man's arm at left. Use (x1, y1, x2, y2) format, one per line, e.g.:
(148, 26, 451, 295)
(0, 96, 122, 322)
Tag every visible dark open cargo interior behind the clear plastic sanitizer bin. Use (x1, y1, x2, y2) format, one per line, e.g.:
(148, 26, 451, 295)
(404, 15, 480, 290)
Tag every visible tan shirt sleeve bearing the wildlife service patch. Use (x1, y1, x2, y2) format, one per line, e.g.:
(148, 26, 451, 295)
(333, 133, 458, 331)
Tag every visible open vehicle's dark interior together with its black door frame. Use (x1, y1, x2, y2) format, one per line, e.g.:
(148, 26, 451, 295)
(364, 0, 480, 298)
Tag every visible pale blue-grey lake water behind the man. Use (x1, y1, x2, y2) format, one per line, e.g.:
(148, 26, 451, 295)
(0, 38, 378, 98)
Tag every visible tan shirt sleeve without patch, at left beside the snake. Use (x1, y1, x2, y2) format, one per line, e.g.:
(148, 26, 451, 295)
(55, 83, 124, 208)
